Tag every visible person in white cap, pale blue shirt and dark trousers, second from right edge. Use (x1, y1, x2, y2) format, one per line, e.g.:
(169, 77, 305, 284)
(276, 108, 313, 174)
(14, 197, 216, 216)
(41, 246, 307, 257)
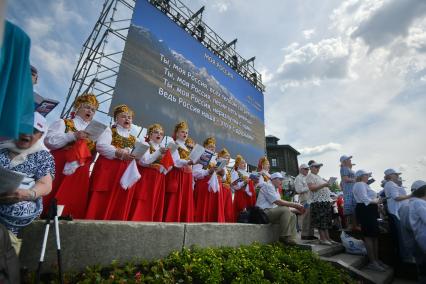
(384, 169, 411, 261)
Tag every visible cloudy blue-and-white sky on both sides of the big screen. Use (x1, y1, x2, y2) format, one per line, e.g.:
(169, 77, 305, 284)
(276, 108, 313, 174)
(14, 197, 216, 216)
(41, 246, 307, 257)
(6, 0, 426, 188)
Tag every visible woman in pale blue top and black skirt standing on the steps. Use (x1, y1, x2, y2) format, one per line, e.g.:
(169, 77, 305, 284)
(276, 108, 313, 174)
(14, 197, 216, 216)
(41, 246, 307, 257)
(353, 170, 387, 271)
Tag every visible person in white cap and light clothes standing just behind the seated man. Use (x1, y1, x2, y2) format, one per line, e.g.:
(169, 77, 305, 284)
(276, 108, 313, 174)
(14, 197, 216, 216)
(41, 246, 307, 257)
(294, 164, 318, 240)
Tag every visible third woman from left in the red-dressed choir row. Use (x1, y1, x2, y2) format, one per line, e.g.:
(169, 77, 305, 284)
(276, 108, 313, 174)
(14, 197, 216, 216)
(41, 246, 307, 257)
(129, 123, 168, 222)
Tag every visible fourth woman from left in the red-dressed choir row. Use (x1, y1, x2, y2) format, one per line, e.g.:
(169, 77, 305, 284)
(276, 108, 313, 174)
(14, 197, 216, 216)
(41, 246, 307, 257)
(163, 122, 194, 222)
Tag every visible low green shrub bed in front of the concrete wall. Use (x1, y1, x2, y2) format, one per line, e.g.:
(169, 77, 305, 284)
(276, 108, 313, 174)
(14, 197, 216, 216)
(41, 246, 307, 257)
(30, 244, 355, 284)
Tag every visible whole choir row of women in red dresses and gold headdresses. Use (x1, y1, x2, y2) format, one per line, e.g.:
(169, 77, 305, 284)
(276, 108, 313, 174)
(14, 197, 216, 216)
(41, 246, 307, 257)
(43, 94, 270, 222)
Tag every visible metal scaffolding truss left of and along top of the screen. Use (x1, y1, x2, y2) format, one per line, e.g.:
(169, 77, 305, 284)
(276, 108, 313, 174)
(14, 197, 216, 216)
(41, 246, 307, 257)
(61, 0, 265, 117)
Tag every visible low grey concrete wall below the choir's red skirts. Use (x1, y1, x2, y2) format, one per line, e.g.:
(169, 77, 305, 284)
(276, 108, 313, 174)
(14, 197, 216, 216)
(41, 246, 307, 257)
(20, 220, 279, 272)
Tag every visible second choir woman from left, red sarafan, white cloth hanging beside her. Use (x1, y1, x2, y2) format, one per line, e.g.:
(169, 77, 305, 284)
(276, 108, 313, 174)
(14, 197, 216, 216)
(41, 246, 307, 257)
(86, 105, 136, 221)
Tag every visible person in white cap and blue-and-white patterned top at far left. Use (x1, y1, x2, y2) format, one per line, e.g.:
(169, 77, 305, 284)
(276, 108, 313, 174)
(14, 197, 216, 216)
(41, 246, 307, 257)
(0, 112, 55, 253)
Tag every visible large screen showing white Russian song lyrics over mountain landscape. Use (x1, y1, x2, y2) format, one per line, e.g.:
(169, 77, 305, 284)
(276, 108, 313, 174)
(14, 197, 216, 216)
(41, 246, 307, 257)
(110, 0, 265, 165)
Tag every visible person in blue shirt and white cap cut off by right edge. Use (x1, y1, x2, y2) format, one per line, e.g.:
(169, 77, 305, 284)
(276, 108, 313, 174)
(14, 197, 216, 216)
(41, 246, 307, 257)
(398, 180, 426, 283)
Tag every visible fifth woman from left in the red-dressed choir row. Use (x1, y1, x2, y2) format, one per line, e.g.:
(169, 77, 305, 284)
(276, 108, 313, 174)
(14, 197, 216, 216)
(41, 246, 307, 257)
(192, 137, 225, 223)
